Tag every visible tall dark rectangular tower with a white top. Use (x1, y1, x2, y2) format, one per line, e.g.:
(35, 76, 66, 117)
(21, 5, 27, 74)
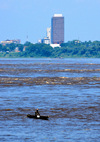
(51, 14, 64, 44)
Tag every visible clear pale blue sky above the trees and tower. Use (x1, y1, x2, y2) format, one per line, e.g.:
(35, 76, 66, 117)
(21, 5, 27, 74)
(0, 0, 100, 44)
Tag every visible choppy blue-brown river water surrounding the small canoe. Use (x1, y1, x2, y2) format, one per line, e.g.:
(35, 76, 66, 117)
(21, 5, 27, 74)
(0, 59, 100, 142)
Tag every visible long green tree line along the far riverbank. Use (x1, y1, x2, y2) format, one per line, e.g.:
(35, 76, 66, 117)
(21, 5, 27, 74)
(0, 40, 100, 58)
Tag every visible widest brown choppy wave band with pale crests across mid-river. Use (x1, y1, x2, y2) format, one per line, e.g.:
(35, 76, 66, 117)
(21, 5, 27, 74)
(0, 77, 100, 86)
